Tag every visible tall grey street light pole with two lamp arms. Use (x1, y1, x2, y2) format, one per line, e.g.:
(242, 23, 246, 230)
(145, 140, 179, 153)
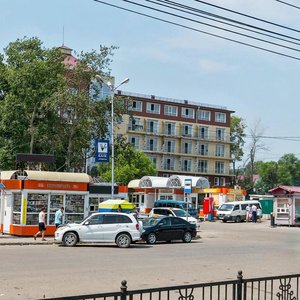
(95, 75, 129, 199)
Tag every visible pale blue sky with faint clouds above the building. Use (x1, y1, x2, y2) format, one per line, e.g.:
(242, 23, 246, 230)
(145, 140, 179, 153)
(0, 0, 300, 164)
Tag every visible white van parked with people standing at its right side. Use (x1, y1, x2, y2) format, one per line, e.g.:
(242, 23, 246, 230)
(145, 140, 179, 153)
(216, 200, 261, 222)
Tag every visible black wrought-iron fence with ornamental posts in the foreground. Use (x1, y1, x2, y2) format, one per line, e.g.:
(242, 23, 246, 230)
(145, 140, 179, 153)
(42, 271, 300, 300)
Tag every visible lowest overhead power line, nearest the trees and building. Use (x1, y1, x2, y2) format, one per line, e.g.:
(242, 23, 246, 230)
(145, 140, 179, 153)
(93, 0, 300, 60)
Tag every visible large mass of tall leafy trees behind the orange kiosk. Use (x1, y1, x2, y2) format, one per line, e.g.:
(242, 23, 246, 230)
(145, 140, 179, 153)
(0, 38, 116, 171)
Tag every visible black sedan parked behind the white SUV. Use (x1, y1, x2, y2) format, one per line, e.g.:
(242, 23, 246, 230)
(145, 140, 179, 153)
(142, 217, 197, 244)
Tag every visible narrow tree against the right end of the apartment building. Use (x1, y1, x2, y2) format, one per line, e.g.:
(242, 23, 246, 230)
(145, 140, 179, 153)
(230, 116, 246, 184)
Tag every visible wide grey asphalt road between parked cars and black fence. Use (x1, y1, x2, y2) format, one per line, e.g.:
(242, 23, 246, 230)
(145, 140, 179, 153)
(0, 221, 300, 300)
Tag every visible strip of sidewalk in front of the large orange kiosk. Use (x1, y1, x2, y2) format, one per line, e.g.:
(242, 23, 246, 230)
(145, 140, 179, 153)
(0, 233, 54, 246)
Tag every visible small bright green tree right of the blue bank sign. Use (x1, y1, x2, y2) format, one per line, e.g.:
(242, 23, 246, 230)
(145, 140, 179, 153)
(98, 138, 157, 185)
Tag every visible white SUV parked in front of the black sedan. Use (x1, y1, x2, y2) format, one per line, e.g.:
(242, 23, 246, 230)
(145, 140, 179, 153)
(54, 212, 143, 248)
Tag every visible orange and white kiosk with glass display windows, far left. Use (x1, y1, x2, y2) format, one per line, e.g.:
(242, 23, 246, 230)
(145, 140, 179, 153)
(0, 170, 91, 236)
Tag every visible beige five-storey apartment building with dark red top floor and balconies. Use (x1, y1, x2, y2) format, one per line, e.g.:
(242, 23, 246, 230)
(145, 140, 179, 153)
(115, 91, 233, 186)
